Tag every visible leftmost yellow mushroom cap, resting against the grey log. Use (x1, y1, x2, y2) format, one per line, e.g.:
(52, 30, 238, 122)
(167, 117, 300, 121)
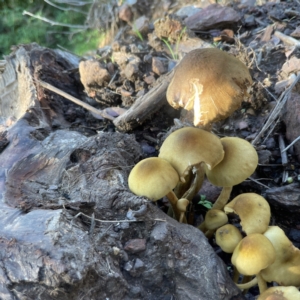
(128, 157, 179, 201)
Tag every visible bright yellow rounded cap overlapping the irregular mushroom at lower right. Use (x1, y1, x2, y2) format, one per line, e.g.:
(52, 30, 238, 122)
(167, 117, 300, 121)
(231, 233, 275, 275)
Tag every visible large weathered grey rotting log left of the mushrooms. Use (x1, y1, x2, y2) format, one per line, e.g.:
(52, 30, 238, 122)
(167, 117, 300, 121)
(0, 45, 244, 300)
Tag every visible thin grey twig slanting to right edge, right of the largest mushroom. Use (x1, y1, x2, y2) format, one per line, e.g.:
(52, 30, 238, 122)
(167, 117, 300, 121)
(252, 74, 300, 145)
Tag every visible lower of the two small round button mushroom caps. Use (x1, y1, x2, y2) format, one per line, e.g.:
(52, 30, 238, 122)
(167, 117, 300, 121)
(216, 224, 243, 253)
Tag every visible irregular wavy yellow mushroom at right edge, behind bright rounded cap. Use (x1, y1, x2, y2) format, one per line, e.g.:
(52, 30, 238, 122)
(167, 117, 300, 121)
(261, 226, 300, 286)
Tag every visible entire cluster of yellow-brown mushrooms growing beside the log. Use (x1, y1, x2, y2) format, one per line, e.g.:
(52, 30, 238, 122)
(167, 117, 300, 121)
(128, 49, 300, 300)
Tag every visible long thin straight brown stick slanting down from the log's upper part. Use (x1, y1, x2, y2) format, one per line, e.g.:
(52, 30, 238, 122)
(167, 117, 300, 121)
(36, 80, 115, 121)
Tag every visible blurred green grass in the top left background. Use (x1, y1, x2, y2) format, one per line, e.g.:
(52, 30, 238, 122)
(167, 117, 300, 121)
(0, 0, 102, 59)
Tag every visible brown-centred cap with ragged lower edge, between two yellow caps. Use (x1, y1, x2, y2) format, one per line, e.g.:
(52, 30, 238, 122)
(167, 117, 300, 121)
(159, 127, 224, 177)
